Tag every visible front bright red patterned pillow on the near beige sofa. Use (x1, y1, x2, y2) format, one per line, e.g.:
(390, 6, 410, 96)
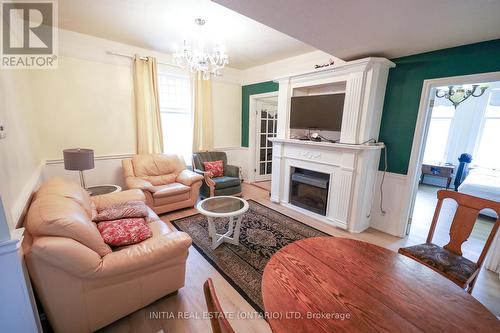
(97, 218, 153, 246)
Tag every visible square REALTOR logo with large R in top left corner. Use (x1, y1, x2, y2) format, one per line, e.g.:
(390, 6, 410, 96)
(1, 0, 57, 69)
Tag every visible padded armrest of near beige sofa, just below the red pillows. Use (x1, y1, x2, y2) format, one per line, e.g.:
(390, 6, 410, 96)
(98, 231, 192, 277)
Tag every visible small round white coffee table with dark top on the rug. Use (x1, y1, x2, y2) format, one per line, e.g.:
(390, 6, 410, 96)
(196, 196, 248, 250)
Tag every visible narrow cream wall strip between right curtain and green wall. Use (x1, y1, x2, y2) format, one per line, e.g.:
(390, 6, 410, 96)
(212, 80, 241, 149)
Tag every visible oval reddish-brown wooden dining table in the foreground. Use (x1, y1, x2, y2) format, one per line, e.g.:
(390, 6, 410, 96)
(262, 237, 500, 333)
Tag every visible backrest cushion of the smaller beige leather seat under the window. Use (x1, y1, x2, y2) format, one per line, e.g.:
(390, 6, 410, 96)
(132, 154, 186, 179)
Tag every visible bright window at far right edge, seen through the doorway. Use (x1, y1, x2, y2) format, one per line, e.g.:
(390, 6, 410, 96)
(473, 89, 500, 169)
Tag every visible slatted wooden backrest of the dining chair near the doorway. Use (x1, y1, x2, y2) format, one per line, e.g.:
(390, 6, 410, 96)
(427, 190, 500, 266)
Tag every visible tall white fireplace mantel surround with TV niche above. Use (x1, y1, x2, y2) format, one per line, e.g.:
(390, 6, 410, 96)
(270, 58, 395, 232)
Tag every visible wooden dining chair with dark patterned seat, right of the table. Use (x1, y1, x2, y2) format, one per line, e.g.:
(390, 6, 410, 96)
(398, 190, 500, 294)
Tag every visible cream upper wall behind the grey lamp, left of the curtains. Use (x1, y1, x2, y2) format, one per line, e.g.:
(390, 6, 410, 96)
(32, 56, 135, 160)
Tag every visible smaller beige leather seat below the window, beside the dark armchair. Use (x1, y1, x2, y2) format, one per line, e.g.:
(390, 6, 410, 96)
(122, 154, 203, 214)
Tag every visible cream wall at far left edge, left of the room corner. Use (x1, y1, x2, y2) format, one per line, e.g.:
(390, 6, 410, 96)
(0, 70, 42, 228)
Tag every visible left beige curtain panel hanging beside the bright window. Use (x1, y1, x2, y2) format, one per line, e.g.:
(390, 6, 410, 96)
(134, 55, 163, 154)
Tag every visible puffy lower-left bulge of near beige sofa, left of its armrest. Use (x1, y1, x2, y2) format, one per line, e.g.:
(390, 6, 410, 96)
(28, 236, 102, 277)
